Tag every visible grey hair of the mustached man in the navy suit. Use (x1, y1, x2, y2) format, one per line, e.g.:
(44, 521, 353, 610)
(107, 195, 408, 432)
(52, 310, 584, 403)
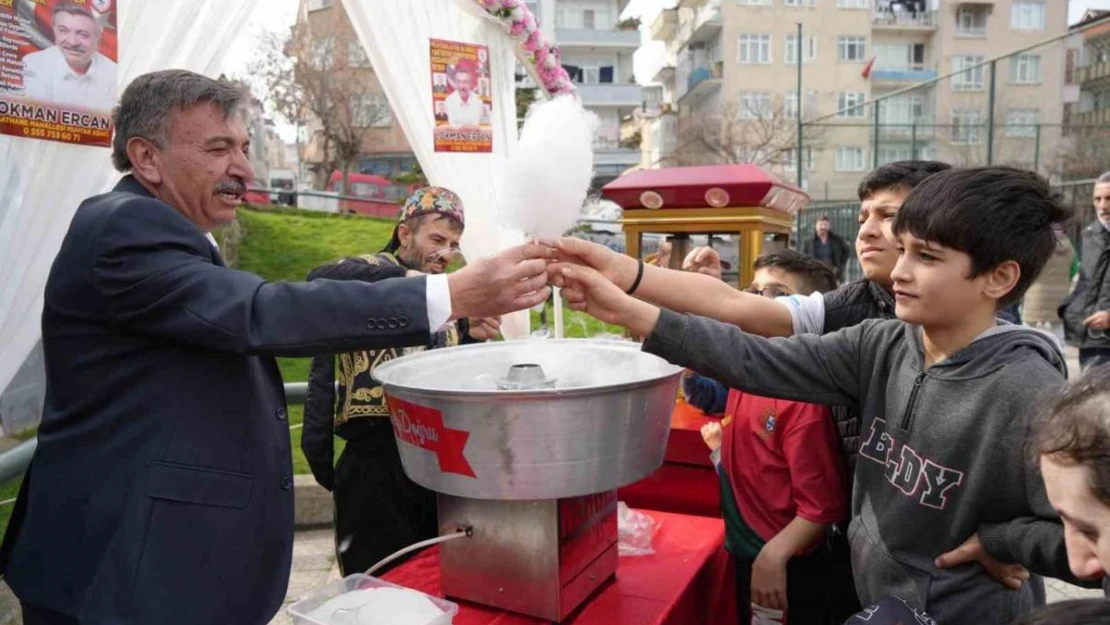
(112, 70, 249, 173)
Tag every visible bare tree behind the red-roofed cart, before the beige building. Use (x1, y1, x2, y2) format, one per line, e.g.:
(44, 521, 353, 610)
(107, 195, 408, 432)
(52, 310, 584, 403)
(659, 100, 823, 168)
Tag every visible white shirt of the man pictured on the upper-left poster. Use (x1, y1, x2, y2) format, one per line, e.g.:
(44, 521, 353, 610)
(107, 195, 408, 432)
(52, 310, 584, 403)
(23, 46, 118, 112)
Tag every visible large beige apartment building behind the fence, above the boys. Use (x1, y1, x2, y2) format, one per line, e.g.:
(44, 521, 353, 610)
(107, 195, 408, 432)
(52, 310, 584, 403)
(642, 0, 1067, 200)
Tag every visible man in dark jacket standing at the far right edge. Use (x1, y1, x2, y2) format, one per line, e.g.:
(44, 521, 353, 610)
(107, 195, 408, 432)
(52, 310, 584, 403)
(1060, 172, 1110, 370)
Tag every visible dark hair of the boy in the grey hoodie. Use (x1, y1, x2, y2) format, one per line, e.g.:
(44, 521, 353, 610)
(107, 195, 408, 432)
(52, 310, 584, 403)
(894, 167, 1071, 308)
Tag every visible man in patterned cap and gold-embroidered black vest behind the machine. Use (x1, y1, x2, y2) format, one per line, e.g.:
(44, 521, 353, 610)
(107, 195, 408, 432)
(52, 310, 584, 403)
(301, 187, 501, 575)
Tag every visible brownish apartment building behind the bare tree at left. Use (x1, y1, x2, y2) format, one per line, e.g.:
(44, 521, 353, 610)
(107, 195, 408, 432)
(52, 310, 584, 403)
(294, 0, 416, 192)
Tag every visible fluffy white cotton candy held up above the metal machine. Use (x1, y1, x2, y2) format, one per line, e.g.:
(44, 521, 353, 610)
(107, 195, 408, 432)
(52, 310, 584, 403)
(497, 95, 597, 239)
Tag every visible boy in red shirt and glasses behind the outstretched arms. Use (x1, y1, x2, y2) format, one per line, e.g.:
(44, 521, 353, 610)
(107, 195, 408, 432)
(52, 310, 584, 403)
(684, 250, 848, 625)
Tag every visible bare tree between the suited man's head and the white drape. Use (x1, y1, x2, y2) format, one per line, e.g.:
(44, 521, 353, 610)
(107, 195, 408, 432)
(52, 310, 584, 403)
(251, 20, 392, 193)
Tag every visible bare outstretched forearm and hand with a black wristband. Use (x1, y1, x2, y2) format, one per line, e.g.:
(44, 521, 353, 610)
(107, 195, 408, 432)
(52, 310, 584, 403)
(554, 238, 794, 336)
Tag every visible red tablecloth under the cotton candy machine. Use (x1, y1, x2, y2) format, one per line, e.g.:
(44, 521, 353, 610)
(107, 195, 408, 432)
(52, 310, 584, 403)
(383, 511, 737, 625)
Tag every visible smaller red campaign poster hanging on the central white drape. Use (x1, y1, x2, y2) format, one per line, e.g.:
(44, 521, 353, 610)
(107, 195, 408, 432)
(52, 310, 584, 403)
(432, 39, 493, 152)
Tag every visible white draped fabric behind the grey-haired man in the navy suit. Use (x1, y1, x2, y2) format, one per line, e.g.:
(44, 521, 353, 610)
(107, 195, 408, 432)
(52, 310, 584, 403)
(0, 0, 258, 391)
